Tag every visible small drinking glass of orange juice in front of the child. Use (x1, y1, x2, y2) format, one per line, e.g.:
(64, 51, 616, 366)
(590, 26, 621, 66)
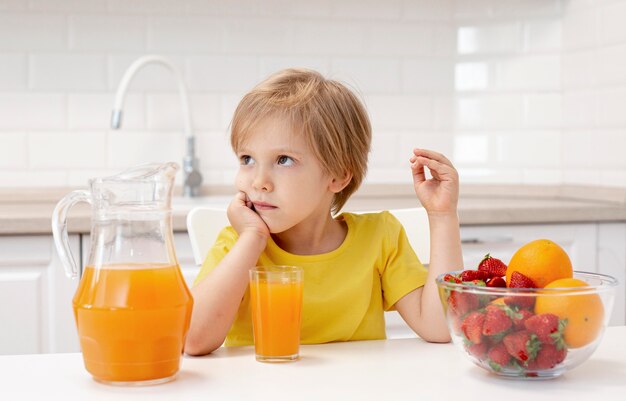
(250, 266, 304, 362)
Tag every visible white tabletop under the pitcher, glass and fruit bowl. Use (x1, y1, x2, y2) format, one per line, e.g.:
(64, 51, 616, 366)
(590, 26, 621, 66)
(0, 326, 626, 401)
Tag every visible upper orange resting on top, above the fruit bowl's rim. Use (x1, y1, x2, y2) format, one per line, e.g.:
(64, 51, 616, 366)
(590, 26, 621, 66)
(506, 239, 573, 288)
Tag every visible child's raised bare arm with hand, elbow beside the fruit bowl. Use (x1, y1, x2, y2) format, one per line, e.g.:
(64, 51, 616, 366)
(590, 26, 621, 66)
(395, 149, 463, 342)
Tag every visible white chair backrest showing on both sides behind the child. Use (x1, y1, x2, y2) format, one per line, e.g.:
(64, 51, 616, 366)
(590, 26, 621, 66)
(187, 206, 430, 265)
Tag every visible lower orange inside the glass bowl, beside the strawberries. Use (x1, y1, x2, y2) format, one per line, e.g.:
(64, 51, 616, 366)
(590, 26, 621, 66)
(535, 278, 604, 348)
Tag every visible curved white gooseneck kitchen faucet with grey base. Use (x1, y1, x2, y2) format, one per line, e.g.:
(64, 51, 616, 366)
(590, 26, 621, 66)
(111, 55, 202, 197)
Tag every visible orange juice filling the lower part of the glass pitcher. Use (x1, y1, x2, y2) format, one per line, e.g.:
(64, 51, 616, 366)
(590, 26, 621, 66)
(73, 265, 191, 382)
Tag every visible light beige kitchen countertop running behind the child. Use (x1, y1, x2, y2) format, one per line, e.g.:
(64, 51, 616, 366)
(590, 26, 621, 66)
(0, 185, 626, 235)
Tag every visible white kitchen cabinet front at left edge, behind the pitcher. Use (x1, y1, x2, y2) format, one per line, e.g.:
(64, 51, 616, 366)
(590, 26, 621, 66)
(0, 235, 80, 354)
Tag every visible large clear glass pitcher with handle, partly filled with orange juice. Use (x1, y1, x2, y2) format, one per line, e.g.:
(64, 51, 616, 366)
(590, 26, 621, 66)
(52, 163, 193, 384)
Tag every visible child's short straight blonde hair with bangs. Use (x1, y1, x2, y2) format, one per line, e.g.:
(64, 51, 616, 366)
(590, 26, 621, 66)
(230, 68, 372, 213)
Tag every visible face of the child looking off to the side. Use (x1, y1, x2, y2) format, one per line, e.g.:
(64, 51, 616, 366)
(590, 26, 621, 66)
(235, 117, 334, 233)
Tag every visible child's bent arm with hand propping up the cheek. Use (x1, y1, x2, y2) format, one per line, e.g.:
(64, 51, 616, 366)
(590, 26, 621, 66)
(185, 193, 269, 355)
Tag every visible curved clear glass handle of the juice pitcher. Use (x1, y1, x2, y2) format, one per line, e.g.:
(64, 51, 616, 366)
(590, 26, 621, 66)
(52, 190, 91, 278)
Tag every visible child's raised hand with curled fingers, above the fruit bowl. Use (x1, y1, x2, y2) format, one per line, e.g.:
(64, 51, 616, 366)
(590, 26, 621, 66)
(409, 149, 459, 213)
